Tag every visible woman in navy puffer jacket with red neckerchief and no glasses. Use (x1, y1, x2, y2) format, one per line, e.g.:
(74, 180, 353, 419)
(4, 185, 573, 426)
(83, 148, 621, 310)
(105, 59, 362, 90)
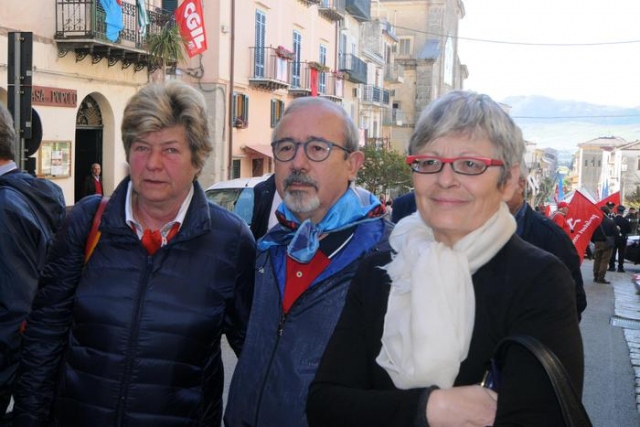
(14, 81, 255, 427)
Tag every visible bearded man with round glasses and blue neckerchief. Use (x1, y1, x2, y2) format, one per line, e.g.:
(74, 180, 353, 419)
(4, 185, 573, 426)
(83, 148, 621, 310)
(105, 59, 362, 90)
(225, 97, 391, 427)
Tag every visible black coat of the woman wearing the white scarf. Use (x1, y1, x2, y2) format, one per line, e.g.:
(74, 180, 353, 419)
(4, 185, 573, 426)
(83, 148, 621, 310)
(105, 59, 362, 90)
(307, 236, 584, 427)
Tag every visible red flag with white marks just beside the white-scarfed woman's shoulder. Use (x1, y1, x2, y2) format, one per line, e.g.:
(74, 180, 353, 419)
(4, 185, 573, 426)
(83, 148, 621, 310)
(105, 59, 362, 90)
(567, 191, 602, 264)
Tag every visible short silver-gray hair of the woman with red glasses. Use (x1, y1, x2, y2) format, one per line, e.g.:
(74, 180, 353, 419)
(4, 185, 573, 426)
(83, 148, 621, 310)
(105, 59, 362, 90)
(409, 90, 525, 185)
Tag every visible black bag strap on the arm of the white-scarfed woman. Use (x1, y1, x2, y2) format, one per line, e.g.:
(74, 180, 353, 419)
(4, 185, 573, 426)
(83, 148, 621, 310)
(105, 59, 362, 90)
(495, 335, 592, 427)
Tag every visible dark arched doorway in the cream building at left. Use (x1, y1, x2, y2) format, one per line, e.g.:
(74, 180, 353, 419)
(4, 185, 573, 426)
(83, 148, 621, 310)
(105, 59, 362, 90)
(73, 95, 104, 202)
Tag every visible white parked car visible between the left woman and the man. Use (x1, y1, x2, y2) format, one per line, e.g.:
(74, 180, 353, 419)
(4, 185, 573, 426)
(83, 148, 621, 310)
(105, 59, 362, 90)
(205, 174, 271, 225)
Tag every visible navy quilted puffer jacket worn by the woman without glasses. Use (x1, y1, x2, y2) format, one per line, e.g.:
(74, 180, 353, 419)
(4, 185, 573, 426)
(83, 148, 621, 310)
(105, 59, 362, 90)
(14, 178, 255, 427)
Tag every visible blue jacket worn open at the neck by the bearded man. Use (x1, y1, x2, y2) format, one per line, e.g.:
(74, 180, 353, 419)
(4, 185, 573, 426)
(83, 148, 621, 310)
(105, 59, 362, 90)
(224, 218, 393, 427)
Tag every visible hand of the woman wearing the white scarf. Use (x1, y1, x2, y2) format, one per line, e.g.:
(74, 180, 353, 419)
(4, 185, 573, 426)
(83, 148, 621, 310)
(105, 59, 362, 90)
(427, 385, 498, 427)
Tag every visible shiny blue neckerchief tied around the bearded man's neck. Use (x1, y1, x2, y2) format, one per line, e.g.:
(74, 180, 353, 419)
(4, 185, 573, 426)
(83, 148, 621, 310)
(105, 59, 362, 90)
(258, 187, 384, 264)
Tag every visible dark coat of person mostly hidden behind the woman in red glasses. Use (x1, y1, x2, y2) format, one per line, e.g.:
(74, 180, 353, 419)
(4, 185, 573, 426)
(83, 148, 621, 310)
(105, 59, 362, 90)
(518, 202, 587, 318)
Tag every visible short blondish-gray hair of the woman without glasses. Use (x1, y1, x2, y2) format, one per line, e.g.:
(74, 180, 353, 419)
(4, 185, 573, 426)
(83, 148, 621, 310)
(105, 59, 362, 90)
(121, 80, 213, 172)
